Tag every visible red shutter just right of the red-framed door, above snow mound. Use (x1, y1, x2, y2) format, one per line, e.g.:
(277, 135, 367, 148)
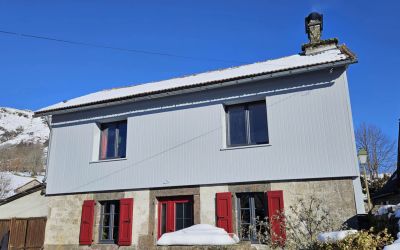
(216, 192, 232, 233)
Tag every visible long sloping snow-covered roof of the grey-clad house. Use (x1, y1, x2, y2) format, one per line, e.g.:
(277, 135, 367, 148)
(35, 45, 356, 116)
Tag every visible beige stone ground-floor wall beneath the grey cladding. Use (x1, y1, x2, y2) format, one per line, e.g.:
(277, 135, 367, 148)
(44, 178, 356, 250)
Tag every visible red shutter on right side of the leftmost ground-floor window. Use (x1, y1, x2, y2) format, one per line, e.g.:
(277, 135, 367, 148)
(118, 198, 133, 246)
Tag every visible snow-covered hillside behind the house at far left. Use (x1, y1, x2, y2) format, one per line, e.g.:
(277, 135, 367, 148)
(0, 107, 49, 148)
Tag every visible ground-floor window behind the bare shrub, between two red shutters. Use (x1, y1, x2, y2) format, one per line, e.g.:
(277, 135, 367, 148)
(237, 193, 266, 242)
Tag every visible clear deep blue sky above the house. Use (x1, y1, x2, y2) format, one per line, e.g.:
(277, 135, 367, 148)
(0, 0, 400, 139)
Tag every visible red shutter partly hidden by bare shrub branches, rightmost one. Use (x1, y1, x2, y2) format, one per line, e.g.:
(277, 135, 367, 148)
(267, 190, 286, 245)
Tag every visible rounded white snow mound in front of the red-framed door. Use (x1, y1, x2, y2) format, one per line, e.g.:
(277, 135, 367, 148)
(157, 224, 239, 246)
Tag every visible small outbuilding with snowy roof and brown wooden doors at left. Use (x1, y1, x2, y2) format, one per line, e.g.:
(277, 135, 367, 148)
(0, 181, 49, 249)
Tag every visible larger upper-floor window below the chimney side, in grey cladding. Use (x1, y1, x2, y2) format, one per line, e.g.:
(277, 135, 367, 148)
(225, 101, 269, 147)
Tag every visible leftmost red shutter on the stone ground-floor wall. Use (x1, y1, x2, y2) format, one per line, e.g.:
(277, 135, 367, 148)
(79, 200, 95, 245)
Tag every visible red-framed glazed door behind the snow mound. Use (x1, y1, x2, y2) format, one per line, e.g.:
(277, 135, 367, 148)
(158, 197, 193, 237)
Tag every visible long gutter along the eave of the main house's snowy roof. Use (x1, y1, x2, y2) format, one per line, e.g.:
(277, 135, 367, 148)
(34, 57, 357, 117)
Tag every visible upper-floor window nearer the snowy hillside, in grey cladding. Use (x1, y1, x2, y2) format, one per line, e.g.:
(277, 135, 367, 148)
(100, 121, 126, 160)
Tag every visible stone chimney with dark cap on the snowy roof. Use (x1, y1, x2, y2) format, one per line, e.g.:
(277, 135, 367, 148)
(301, 12, 338, 55)
